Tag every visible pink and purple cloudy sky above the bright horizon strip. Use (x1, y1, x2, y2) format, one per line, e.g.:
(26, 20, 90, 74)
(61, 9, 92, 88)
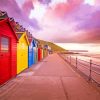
(0, 0, 100, 52)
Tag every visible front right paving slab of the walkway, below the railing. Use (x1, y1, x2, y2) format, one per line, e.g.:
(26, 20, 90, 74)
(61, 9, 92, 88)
(62, 77, 100, 100)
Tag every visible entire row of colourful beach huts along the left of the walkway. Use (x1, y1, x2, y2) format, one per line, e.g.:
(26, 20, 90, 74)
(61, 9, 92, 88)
(0, 11, 50, 85)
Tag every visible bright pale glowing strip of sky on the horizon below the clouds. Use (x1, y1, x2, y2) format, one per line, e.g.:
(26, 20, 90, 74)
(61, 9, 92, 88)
(56, 43, 100, 54)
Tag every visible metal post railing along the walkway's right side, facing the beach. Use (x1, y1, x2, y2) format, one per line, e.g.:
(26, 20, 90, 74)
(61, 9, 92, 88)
(59, 54, 100, 86)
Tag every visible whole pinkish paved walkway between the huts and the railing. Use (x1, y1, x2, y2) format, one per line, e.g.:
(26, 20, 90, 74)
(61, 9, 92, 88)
(0, 54, 100, 100)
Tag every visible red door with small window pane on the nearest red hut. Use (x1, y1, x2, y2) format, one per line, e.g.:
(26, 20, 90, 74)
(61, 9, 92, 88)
(0, 36, 11, 84)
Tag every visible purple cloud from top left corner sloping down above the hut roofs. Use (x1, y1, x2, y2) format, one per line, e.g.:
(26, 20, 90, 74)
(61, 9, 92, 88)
(0, 0, 40, 31)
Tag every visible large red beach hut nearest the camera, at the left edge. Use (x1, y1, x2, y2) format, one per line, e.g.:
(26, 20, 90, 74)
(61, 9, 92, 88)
(0, 14, 18, 84)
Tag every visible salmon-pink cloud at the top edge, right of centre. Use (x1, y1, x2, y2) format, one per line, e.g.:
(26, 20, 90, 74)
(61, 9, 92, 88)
(49, 0, 84, 17)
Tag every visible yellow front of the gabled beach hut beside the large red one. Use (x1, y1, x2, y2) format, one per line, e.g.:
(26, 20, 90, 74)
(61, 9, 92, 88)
(17, 35, 28, 73)
